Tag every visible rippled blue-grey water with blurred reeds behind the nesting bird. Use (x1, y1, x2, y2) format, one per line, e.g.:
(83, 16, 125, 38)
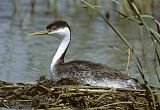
(0, 0, 160, 86)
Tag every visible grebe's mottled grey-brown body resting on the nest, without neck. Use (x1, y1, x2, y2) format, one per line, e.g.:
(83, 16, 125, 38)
(51, 61, 141, 89)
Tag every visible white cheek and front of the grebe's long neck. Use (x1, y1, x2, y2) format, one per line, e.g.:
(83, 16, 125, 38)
(48, 27, 71, 72)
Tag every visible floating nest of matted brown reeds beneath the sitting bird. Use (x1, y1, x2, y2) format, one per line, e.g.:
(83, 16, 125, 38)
(0, 77, 156, 110)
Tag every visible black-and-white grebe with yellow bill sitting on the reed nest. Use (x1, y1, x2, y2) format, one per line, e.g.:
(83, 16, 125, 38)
(29, 20, 142, 89)
